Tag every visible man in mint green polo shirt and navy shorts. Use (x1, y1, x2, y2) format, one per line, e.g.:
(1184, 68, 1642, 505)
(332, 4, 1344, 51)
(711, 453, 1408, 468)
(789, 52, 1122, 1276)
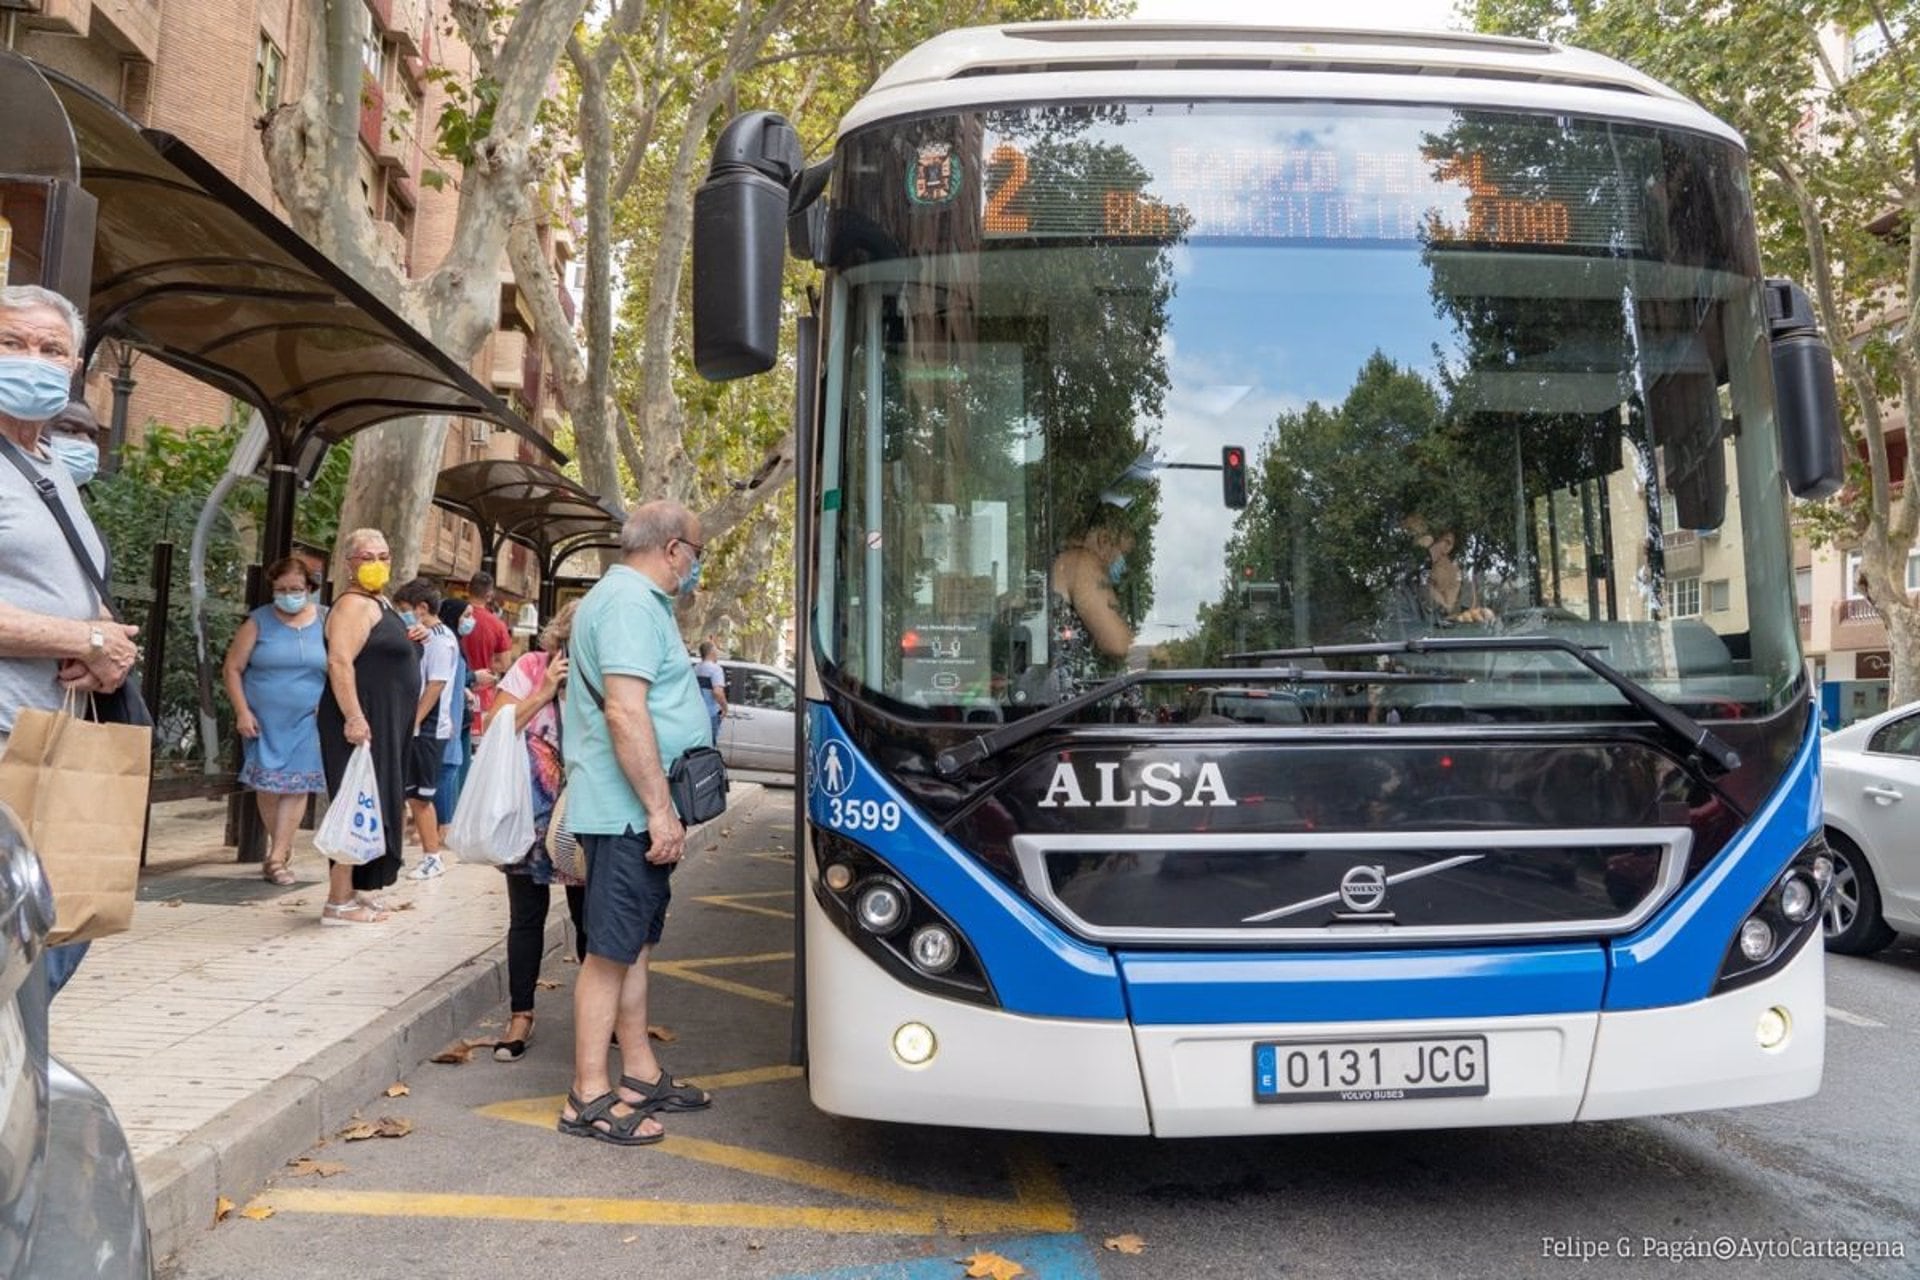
(559, 501, 712, 1146)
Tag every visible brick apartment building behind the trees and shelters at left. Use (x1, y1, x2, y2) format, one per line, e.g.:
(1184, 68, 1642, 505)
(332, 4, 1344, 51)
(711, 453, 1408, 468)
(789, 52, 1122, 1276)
(0, 0, 574, 599)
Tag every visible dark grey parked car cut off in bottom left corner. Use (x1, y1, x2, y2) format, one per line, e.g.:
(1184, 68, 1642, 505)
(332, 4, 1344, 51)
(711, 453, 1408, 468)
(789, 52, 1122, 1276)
(0, 804, 154, 1280)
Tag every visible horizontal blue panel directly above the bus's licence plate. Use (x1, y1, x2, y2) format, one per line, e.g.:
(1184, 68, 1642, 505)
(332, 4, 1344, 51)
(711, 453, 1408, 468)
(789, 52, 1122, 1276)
(1119, 942, 1607, 1027)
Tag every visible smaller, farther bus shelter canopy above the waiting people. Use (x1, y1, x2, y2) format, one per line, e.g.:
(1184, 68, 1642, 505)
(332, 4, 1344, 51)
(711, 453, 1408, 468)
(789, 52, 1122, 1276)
(434, 459, 620, 618)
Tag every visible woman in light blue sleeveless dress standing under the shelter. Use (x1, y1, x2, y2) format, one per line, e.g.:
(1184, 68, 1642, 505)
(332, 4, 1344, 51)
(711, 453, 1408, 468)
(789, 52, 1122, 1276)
(221, 557, 326, 885)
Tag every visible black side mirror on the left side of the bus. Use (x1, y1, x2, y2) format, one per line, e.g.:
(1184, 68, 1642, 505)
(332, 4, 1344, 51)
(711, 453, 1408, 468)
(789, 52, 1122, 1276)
(693, 111, 804, 382)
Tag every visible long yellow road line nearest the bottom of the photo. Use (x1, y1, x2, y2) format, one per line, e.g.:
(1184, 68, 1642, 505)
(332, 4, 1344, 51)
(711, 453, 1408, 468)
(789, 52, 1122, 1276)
(253, 1188, 1073, 1236)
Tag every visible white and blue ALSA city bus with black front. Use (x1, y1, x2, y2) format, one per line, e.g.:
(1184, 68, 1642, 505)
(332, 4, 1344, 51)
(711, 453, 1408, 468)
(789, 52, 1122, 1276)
(693, 23, 1843, 1136)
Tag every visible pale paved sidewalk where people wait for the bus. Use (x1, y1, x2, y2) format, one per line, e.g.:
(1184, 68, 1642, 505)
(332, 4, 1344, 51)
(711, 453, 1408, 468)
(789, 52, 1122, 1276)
(50, 800, 564, 1257)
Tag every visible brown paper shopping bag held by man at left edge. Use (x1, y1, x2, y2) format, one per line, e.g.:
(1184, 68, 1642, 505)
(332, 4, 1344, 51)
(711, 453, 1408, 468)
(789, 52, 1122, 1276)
(0, 699, 154, 942)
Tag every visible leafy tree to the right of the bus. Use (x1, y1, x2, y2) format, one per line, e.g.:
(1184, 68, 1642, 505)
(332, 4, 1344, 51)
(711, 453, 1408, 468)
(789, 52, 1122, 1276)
(1469, 0, 1920, 702)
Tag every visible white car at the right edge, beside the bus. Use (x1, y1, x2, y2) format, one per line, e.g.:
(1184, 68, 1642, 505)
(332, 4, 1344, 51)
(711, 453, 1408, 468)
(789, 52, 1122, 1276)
(1820, 702, 1920, 956)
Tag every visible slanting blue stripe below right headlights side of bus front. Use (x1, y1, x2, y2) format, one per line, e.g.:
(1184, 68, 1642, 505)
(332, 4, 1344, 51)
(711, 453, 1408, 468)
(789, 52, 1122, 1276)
(1607, 712, 1822, 1009)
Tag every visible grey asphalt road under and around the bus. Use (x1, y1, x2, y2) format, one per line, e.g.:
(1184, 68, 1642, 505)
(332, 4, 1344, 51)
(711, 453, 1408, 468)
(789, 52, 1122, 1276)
(163, 791, 1920, 1280)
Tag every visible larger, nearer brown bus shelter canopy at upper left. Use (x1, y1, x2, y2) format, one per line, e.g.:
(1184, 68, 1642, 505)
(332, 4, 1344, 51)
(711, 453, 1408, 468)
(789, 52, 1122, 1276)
(0, 54, 564, 562)
